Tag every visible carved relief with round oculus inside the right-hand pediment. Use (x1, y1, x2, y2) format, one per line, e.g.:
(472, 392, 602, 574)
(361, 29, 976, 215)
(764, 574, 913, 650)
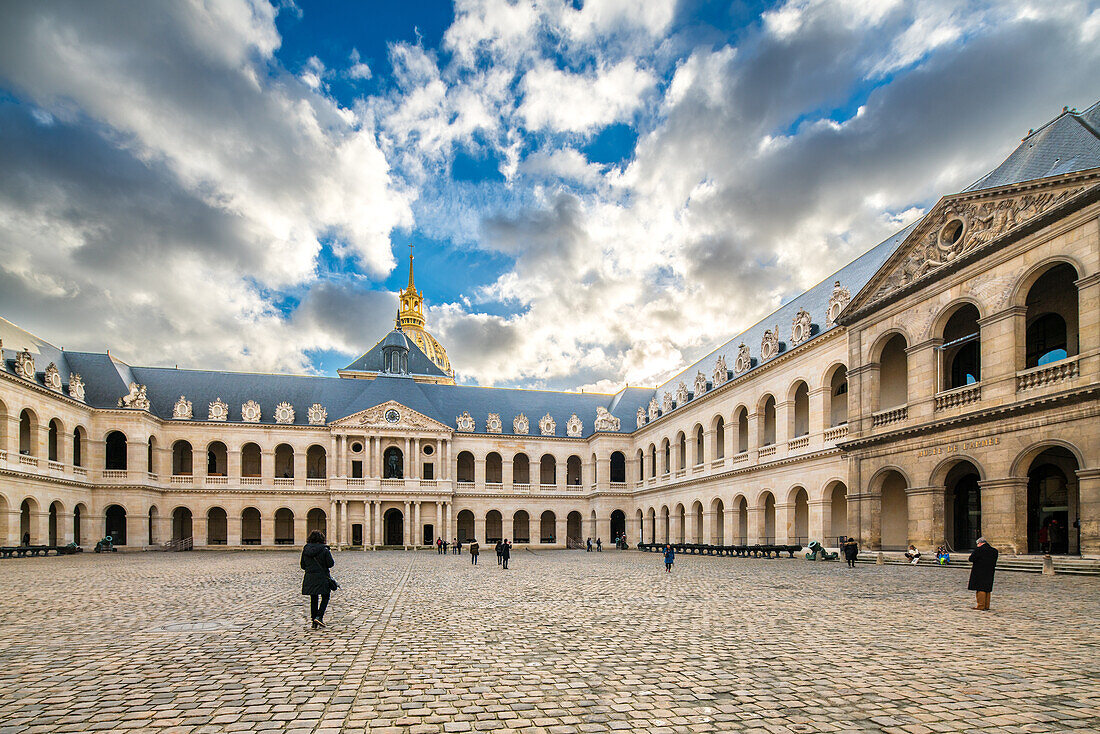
(871, 186, 1086, 302)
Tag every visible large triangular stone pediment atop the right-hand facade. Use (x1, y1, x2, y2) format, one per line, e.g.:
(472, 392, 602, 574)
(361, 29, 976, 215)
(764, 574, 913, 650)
(839, 171, 1100, 322)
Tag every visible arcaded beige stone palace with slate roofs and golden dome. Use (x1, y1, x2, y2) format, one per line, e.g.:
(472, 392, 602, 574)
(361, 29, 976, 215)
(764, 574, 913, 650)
(0, 105, 1100, 555)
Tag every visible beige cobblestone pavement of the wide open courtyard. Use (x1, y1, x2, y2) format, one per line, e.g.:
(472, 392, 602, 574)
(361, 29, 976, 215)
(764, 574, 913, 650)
(0, 550, 1100, 734)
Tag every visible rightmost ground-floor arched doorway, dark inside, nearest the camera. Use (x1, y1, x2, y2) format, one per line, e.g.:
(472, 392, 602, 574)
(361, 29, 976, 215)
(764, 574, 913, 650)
(1027, 446, 1081, 555)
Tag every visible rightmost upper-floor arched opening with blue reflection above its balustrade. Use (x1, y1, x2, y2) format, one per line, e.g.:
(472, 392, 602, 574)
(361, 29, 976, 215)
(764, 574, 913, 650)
(1024, 263, 1078, 369)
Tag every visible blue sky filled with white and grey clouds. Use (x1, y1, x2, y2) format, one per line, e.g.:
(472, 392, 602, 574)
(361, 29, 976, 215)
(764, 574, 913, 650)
(0, 0, 1100, 390)
